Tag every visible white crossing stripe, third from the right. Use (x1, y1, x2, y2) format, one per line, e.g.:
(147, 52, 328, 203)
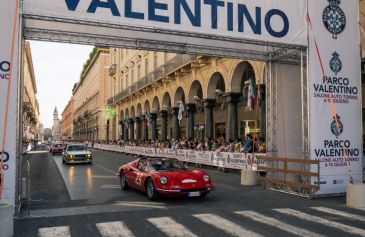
(235, 211, 324, 237)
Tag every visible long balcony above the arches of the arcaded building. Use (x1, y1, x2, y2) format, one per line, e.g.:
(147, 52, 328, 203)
(107, 54, 200, 105)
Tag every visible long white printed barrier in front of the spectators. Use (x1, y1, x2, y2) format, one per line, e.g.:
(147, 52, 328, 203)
(94, 144, 266, 171)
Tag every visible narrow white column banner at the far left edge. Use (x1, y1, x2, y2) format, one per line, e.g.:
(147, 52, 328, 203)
(0, 0, 20, 205)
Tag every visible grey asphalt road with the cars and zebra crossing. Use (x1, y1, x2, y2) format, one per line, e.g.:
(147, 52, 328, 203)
(15, 144, 365, 237)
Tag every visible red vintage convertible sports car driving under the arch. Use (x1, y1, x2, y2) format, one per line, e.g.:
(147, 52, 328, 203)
(117, 157, 214, 200)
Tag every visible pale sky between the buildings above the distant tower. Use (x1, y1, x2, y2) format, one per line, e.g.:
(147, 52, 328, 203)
(30, 41, 93, 128)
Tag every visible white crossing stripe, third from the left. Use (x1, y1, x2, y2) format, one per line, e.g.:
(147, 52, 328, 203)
(147, 217, 197, 237)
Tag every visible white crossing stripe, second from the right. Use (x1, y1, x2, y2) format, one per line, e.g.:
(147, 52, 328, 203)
(273, 208, 365, 236)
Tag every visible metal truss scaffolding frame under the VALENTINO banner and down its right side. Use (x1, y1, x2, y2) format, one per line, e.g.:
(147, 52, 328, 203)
(16, 8, 312, 204)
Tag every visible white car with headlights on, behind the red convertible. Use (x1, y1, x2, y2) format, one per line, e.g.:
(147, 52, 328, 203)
(62, 144, 92, 164)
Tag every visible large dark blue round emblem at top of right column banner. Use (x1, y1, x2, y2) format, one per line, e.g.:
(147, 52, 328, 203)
(322, 0, 346, 39)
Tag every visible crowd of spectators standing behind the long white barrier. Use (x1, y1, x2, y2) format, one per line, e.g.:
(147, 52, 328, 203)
(94, 134, 266, 153)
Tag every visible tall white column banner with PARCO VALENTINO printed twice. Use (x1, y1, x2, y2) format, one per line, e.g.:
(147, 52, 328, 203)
(308, 0, 362, 195)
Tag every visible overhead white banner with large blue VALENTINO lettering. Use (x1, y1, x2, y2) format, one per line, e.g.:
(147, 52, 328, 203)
(24, 0, 307, 46)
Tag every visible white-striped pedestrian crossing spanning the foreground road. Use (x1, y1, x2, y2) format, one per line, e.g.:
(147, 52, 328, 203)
(38, 207, 365, 237)
